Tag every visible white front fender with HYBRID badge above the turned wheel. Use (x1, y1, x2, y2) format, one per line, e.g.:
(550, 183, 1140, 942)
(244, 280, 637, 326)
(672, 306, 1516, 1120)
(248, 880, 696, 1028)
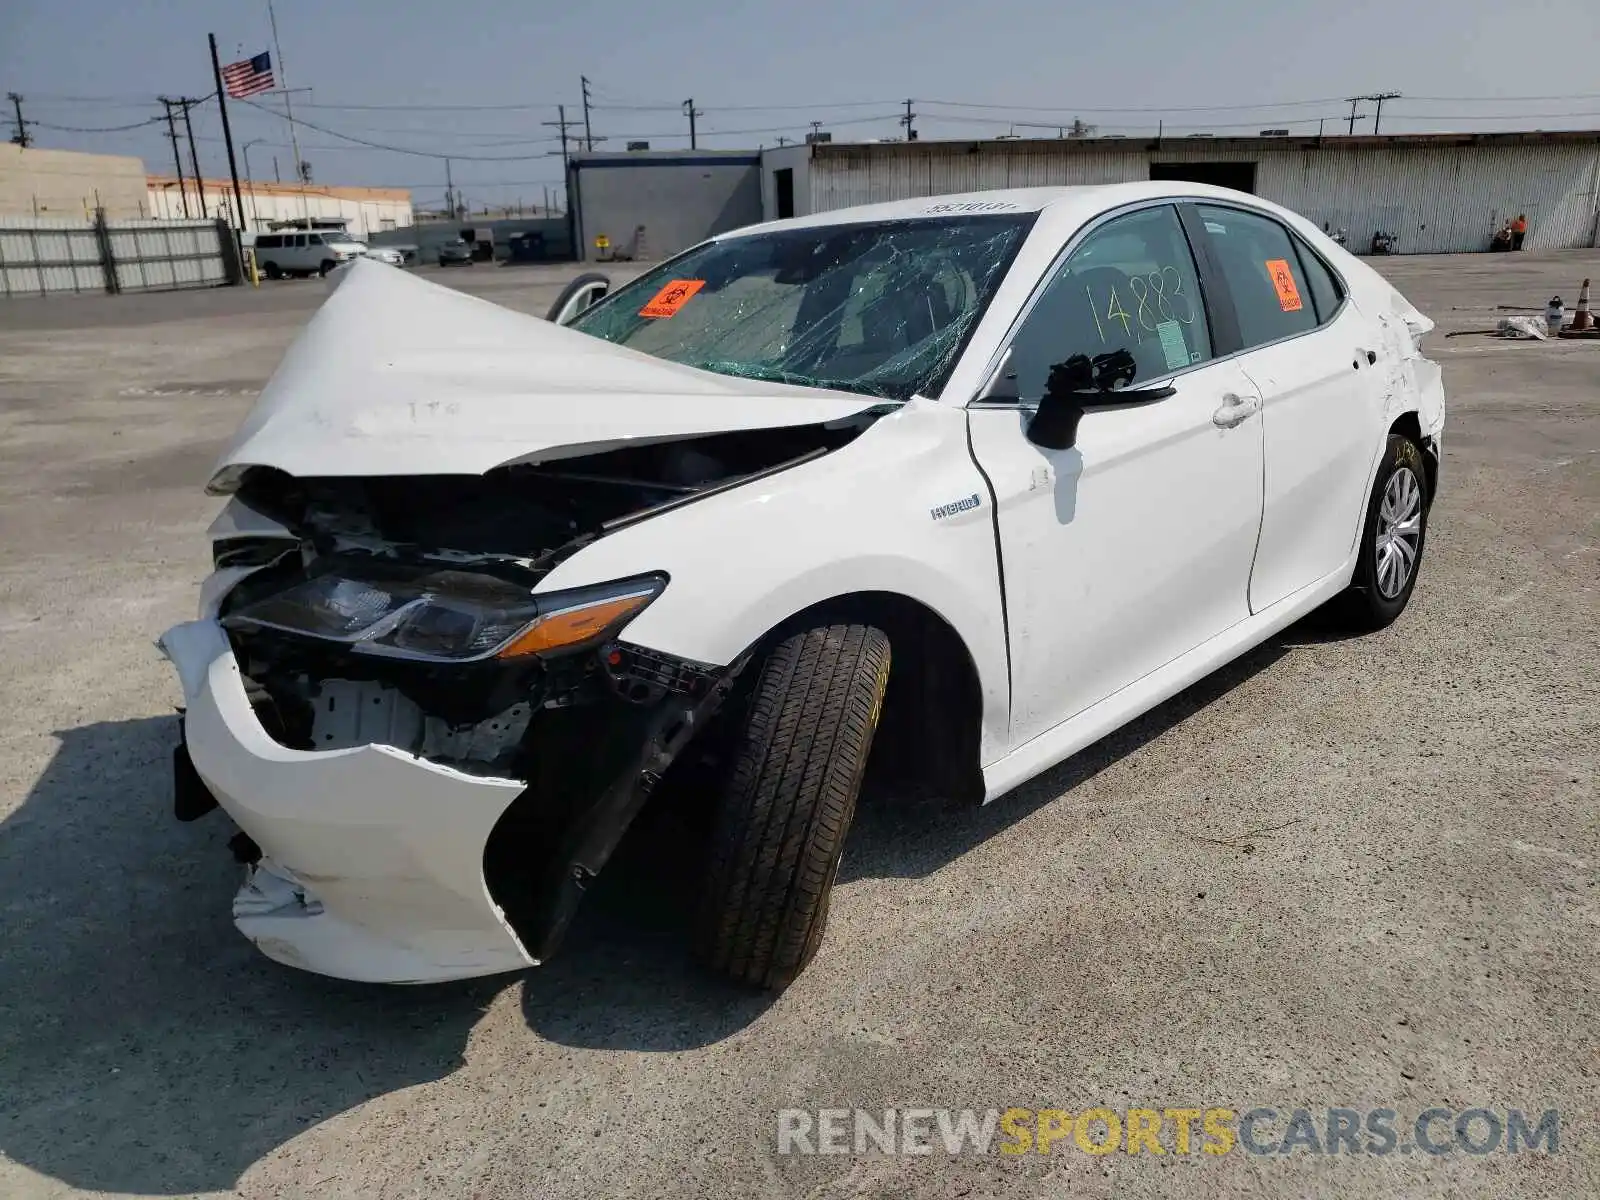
(539, 398, 1010, 762)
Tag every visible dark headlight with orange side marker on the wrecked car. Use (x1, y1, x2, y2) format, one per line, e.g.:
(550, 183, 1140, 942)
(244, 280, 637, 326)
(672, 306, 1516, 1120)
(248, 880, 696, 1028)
(222, 570, 667, 662)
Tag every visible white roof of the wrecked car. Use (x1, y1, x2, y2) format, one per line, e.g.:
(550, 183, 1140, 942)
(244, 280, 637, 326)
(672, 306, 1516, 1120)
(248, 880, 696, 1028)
(723, 181, 1272, 237)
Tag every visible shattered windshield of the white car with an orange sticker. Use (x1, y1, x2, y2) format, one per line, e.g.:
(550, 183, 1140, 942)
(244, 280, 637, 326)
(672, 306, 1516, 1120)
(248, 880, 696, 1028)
(573, 213, 1034, 400)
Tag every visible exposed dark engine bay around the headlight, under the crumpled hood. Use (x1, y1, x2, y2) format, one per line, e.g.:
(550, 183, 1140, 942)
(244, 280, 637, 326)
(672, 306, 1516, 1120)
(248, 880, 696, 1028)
(216, 413, 878, 778)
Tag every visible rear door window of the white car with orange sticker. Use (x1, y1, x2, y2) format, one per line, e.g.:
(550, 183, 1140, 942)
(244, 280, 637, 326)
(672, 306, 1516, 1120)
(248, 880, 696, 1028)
(1198, 205, 1317, 349)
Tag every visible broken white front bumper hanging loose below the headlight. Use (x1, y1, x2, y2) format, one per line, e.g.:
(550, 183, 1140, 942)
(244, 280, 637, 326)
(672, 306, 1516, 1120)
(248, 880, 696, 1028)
(160, 621, 534, 982)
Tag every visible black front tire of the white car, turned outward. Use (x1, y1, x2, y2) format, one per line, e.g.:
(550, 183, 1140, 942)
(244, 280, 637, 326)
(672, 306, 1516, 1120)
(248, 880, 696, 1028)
(698, 626, 890, 990)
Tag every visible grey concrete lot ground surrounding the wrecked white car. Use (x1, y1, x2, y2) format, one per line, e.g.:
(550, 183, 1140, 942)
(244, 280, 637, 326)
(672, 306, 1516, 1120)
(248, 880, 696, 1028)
(0, 251, 1600, 1200)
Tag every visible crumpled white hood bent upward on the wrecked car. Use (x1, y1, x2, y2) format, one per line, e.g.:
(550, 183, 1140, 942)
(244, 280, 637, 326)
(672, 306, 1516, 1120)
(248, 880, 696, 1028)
(211, 259, 883, 491)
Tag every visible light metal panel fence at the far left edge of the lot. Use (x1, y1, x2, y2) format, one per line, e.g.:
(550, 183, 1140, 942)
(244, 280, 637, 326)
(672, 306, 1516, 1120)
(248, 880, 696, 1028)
(0, 211, 243, 296)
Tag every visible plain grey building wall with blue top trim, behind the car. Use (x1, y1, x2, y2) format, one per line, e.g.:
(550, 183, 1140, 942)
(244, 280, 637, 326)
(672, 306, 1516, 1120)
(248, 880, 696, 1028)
(568, 150, 762, 261)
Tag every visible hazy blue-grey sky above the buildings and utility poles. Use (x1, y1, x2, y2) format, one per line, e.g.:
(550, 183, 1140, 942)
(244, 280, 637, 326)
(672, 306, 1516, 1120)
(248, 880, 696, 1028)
(0, 0, 1600, 205)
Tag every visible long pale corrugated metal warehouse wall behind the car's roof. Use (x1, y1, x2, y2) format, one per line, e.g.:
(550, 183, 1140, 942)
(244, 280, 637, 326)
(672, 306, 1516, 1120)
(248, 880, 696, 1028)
(810, 138, 1600, 254)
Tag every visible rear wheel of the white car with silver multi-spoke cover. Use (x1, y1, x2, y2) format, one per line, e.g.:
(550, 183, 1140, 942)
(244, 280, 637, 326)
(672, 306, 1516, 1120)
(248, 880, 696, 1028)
(1339, 434, 1430, 630)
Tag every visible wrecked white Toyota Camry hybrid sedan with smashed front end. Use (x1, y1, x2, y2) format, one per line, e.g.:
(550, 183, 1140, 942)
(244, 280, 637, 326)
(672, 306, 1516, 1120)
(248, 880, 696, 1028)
(162, 182, 1445, 987)
